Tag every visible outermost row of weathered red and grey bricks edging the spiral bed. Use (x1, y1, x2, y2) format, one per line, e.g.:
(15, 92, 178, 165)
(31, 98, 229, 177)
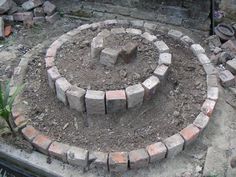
(11, 20, 219, 172)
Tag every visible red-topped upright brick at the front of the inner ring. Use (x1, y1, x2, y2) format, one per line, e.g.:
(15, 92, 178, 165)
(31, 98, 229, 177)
(106, 90, 126, 113)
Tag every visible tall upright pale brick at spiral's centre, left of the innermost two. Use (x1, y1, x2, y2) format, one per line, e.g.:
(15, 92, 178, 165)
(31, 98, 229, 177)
(91, 36, 104, 61)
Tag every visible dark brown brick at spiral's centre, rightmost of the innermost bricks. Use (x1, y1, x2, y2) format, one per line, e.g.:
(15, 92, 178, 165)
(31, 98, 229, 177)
(120, 42, 138, 63)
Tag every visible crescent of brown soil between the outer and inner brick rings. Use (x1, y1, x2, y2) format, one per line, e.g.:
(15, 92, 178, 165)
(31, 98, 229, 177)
(23, 25, 206, 151)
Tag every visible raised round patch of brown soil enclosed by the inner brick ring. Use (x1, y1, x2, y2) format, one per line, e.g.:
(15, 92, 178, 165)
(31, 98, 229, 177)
(56, 29, 159, 90)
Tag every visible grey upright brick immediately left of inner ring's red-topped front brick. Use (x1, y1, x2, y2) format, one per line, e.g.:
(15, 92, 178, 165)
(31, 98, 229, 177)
(85, 90, 105, 114)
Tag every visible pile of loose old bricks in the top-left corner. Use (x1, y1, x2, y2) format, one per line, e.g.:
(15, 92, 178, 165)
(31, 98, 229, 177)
(0, 0, 60, 39)
